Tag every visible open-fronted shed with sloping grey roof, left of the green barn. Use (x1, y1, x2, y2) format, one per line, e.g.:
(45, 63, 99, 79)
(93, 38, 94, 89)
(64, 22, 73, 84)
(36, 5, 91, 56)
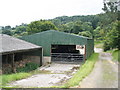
(0, 34, 42, 73)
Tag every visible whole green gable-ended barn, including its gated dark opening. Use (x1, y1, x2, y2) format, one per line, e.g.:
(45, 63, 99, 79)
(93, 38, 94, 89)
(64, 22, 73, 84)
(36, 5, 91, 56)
(21, 30, 94, 62)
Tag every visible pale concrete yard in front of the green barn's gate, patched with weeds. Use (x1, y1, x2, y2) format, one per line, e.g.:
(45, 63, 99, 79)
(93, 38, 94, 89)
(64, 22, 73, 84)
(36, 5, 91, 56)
(9, 63, 80, 88)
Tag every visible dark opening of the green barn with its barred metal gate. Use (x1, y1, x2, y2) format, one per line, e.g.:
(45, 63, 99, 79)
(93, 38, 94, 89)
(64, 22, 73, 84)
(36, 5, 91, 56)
(51, 45, 84, 62)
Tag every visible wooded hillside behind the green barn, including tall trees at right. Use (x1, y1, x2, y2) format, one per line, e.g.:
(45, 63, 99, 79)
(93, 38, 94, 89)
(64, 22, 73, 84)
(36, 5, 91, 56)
(0, 2, 120, 51)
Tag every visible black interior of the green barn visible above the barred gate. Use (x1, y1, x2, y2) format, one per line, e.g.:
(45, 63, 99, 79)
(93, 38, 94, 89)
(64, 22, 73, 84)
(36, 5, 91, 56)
(51, 45, 79, 53)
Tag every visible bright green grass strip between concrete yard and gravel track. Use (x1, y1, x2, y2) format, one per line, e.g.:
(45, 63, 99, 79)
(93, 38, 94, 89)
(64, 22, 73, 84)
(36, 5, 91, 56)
(62, 53, 99, 88)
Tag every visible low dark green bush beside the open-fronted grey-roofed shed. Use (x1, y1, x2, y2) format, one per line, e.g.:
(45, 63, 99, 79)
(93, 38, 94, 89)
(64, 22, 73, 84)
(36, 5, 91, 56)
(17, 62, 39, 72)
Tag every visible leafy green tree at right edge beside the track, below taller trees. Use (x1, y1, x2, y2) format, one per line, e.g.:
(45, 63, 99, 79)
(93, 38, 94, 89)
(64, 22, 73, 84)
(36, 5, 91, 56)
(104, 21, 120, 51)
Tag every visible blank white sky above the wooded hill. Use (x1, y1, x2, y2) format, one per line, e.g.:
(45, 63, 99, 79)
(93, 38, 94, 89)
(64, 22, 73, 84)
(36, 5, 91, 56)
(0, 0, 103, 26)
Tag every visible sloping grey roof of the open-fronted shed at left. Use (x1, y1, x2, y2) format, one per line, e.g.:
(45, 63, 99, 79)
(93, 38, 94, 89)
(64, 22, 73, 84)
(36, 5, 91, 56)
(0, 34, 41, 53)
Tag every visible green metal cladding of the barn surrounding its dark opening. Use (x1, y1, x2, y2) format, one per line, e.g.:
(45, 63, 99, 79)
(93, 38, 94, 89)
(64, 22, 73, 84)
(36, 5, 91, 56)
(21, 30, 94, 59)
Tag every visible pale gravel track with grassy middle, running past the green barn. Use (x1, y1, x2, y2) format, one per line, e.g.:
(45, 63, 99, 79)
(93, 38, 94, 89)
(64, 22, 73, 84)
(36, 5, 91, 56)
(77, 48, 118, 88)
